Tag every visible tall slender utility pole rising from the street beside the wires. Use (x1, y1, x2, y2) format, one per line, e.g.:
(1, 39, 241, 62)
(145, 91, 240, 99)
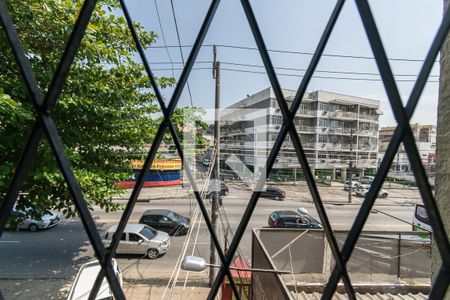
(209, 46, 220, 286)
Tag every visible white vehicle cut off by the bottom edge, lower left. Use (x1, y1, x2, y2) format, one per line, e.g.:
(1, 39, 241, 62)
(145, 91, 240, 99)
(67, 258, 123, 300)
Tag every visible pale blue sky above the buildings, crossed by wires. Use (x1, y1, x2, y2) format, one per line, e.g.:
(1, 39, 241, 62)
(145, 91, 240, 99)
(122, 0, 443, 126)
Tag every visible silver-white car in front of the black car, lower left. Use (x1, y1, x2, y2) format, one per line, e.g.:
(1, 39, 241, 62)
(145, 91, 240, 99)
(104, 224, 170, 259)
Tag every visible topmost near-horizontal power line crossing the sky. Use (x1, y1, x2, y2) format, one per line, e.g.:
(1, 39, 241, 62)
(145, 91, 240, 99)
(152, 44, 439, 62)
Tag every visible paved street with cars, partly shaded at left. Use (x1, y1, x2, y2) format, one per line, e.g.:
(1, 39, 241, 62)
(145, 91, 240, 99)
(0, 185, 419, 299)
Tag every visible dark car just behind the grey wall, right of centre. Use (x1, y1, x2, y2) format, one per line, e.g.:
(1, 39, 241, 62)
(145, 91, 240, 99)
(268, 209, 322, 229)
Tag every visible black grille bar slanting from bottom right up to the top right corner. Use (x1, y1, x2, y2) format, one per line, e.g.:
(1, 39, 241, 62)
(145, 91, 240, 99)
(323, 0, 450, 299)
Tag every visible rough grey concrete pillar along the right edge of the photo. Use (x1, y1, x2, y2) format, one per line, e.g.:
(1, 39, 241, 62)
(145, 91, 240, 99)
(431, 0, 450, 299)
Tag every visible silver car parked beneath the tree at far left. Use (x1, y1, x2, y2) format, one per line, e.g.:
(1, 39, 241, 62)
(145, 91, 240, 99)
(6, 208, 60, 232)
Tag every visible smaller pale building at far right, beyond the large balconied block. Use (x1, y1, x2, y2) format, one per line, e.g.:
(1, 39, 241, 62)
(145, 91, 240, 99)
(378, 124, 436, 173)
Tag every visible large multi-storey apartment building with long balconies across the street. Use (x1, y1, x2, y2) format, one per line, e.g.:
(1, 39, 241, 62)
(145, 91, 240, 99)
(221, 88, 381, 178)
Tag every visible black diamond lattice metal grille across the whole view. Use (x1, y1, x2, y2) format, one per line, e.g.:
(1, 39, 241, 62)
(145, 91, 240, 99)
(0, 0, 450, 299)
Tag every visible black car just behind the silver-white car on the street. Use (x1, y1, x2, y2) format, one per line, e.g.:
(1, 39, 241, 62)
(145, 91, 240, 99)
(139, 209, 191, 235)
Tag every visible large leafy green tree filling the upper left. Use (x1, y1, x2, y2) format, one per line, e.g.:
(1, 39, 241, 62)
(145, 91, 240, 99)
(0, 0, 175, 216)
